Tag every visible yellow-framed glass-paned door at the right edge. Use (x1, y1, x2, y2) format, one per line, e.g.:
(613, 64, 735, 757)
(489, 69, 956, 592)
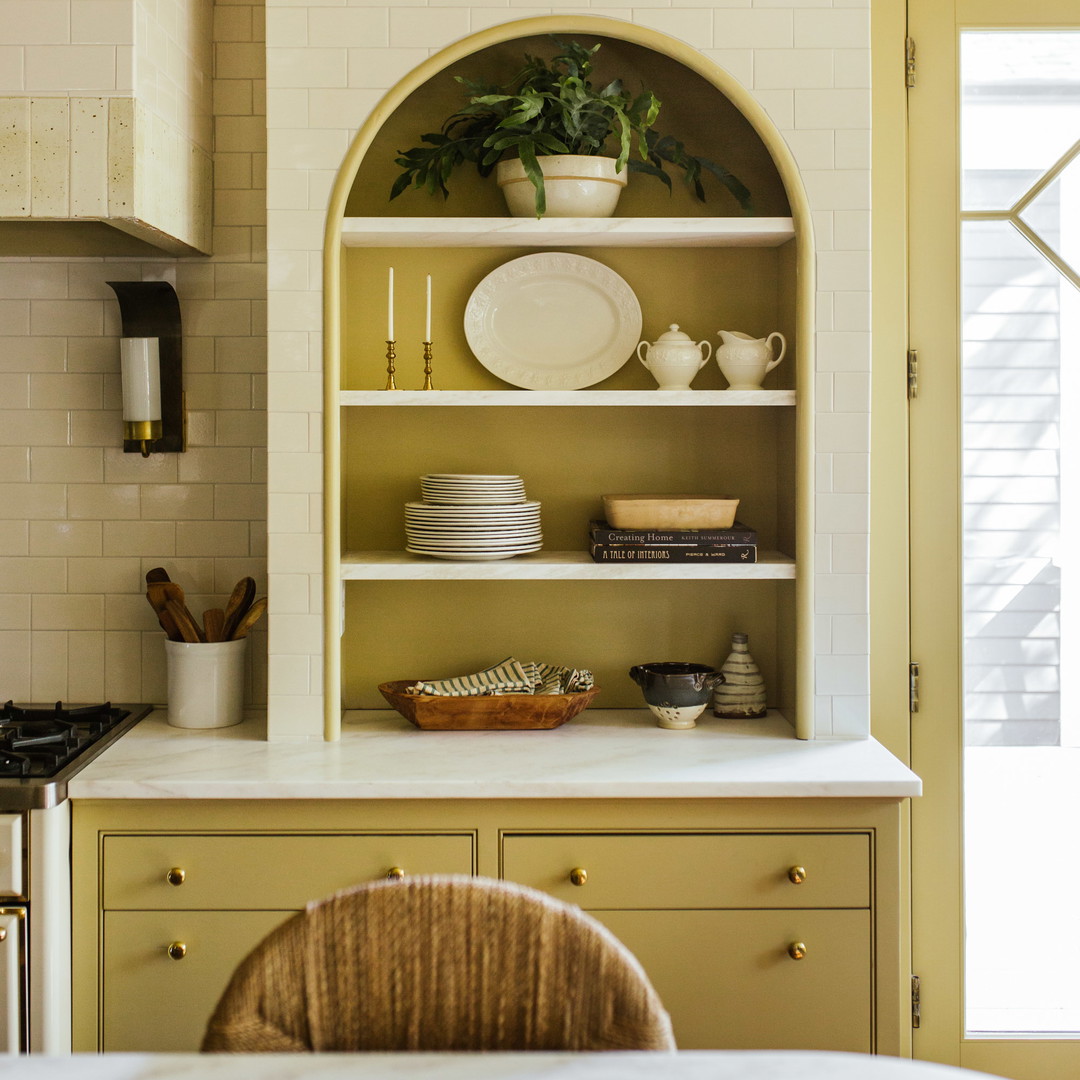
(909, 0, 1080, 1078)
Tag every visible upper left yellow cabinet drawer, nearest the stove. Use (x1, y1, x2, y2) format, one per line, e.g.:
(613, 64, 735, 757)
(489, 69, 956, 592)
(103, 833, 473, 910)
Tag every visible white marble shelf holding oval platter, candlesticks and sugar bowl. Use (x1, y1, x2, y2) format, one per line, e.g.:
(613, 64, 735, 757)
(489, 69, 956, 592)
(338, 390, 795, 408)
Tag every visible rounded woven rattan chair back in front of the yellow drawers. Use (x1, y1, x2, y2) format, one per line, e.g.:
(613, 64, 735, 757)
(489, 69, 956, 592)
(202, 876, 675, 1052)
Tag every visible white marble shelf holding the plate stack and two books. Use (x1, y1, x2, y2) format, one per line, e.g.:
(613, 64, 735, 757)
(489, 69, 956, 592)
(341, 551, 796, 581)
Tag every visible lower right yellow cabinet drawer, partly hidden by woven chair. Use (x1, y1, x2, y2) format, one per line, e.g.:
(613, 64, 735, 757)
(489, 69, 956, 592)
(592, 910, 874, 1053)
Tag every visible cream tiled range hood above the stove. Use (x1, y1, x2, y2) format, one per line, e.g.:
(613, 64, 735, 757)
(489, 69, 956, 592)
(0, 0, 213, 256)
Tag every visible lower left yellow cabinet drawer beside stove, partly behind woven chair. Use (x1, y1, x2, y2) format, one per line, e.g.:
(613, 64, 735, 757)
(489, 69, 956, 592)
(100, 912, 294, 1052)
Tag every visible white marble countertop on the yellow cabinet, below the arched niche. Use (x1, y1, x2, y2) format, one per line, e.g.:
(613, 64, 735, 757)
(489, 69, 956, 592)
(68, 710, 921, 799)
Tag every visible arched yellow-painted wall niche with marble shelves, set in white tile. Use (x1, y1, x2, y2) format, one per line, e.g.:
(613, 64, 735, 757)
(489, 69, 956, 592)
(324, 17, 813, 738)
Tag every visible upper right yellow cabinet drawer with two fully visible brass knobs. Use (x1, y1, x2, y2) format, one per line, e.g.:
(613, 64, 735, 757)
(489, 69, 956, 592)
(502, 833, 870, 910)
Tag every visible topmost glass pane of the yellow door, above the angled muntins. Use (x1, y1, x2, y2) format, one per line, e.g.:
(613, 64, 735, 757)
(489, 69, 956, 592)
(960, 30, 1080, 211)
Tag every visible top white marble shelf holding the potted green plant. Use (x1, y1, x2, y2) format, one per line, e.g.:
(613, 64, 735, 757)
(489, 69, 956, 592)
(341, 217, 795, 247)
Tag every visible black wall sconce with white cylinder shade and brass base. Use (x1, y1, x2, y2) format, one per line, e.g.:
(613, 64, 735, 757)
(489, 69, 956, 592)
(106, 281, 188, 458)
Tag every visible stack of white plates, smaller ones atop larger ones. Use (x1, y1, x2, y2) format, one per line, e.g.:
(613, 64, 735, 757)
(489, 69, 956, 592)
(405, 474, 543, 562)
